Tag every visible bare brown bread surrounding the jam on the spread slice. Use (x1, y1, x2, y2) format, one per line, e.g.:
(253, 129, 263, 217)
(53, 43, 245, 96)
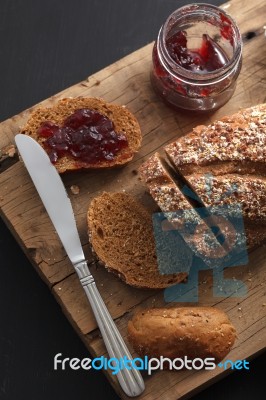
(21, 97, 142, 173)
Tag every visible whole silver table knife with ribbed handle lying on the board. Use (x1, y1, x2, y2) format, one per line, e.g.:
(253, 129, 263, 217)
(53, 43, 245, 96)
(15, 134, 145, 397)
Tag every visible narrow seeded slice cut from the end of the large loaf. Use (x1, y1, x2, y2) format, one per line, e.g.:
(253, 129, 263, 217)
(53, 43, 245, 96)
(139, 153, 227, 266)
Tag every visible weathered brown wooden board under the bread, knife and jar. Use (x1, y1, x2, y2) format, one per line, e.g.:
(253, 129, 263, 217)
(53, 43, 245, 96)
(0, 0, 266, 400)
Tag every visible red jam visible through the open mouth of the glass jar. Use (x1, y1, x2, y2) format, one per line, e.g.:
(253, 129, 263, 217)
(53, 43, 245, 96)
(166, 31, 229, 73)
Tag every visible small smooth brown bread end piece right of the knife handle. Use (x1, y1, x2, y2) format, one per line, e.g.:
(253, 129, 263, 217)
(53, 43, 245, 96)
(128, 307, 236, 362)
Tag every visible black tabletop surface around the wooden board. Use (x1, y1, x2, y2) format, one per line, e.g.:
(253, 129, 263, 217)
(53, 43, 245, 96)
(0, 0, 266, 400)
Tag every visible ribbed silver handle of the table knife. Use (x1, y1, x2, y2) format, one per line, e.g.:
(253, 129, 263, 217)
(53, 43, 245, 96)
(74, 261, 145, 397)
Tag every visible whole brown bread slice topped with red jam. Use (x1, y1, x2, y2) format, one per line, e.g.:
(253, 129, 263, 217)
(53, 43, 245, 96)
(21, 97, 142, 173)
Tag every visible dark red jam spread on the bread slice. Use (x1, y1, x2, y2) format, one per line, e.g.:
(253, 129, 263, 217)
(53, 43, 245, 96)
(38, 108, 128, 164)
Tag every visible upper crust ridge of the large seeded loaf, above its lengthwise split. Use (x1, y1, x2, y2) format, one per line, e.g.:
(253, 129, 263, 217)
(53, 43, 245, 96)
(165, 104, 266, 176)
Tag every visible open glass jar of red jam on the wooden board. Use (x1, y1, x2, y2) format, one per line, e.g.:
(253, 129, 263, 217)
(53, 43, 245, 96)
(151, 3, 243, 112)
